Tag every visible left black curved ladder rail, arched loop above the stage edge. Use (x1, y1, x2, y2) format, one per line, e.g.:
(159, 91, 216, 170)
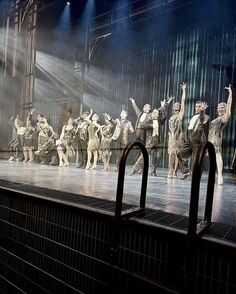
(115, 141, 149, 219)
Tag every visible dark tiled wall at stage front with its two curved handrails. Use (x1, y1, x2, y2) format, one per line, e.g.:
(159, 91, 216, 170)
(0, 143, 236, 294)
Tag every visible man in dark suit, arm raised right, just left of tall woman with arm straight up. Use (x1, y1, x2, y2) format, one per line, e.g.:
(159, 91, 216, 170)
(130, 96, 174, 176)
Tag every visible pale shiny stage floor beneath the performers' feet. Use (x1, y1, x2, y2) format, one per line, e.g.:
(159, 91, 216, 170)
(0, 160, 236, 226)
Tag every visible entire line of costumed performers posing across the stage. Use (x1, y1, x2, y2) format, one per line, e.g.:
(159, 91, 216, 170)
(9, 83, 232, 185)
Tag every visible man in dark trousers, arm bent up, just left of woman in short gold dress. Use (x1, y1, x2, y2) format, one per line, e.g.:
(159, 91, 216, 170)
(75, 111, 93, 168)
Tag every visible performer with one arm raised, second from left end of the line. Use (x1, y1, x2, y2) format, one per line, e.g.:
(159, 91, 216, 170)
(23, 108, 37, 163)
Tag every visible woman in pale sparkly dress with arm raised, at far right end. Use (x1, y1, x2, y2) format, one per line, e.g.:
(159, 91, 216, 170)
(208, 85, 232, 185)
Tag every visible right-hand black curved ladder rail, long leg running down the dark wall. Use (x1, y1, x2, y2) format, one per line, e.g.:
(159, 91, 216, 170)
(184, 142, 216, 293)
